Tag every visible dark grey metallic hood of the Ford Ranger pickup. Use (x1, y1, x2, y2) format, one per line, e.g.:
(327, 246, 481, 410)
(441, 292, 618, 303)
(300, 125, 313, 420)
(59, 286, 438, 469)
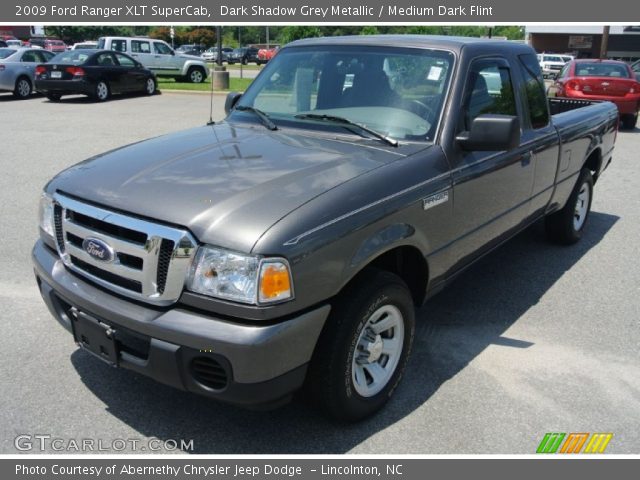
(47, 123, 411, 252)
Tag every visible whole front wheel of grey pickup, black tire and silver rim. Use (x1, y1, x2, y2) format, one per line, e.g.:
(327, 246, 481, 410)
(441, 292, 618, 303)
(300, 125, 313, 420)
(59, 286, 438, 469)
(307, 269, 415, 421)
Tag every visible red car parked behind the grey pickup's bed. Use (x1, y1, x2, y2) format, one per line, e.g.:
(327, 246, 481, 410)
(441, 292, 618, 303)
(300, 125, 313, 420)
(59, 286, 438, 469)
(549, 60, 640, 129)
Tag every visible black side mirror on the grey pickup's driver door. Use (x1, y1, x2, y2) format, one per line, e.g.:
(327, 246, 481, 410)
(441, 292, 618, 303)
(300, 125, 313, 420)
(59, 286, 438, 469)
(456, 114, 520, 152)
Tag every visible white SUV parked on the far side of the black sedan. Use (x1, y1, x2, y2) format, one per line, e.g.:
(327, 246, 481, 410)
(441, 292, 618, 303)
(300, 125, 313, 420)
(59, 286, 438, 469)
(98, 37, 207, 83)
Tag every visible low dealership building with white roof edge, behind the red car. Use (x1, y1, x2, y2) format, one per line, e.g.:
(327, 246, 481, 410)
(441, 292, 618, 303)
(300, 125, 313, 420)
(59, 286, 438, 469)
(525, 25, 640, 60)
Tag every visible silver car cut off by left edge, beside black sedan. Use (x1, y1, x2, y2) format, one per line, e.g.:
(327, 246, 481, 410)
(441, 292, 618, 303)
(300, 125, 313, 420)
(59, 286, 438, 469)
(0, 48, 55, 99)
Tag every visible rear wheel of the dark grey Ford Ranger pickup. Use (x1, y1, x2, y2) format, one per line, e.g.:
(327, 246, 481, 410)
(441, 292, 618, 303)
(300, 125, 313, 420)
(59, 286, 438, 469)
(545, 168, 593, 245)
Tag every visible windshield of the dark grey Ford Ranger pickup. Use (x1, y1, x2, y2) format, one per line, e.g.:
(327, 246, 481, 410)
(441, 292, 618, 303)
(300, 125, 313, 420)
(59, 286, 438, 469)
(234, 45, 453, 141)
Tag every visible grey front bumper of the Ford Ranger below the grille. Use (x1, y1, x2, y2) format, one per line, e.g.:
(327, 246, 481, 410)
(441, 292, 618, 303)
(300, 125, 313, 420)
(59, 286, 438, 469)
(32, 240, 330, 406)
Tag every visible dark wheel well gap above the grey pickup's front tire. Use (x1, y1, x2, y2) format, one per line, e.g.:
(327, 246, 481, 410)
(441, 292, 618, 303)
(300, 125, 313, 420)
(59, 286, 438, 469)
(365, 246, 429, 306)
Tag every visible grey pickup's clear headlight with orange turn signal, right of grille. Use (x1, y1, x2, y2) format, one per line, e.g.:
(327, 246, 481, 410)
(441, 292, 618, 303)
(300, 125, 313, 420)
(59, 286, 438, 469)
(187, 247, 293, 304)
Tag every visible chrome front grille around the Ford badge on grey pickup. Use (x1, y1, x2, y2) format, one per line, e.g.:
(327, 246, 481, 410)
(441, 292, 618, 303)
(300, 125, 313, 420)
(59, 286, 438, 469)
(54, 193, 196, 305)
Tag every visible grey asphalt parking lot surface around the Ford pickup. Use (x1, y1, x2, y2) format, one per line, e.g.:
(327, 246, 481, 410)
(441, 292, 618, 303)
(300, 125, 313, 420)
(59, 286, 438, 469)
(0, 93, 640, 454)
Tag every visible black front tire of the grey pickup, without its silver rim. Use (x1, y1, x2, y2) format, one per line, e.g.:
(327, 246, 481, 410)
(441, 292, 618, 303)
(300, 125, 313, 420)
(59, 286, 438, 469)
(306, 269, 415, 421)
